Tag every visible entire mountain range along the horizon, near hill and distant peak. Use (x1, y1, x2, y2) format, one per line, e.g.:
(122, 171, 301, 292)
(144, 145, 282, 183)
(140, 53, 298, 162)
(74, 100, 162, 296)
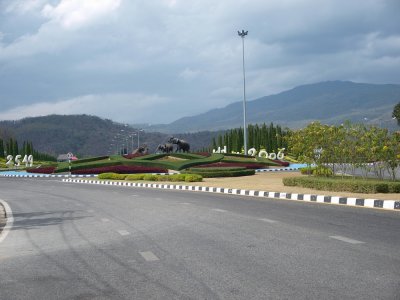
(0, 81, 400, 157)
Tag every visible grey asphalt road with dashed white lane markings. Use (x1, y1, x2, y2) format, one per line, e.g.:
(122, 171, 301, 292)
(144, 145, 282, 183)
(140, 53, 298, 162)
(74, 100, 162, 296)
(0, 178, 400, 300)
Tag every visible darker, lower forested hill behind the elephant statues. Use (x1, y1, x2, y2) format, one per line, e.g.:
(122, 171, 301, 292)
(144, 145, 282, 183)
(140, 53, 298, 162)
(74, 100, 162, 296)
(0, 115, 217, 157)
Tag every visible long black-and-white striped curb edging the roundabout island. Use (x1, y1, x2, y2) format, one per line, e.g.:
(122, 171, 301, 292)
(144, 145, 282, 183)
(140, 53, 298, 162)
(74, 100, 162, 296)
(62, 179, 400, 211)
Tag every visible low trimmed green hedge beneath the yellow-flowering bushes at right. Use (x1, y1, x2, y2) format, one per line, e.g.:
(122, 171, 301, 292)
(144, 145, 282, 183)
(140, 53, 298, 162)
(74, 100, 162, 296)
(283, 176, 400, 194)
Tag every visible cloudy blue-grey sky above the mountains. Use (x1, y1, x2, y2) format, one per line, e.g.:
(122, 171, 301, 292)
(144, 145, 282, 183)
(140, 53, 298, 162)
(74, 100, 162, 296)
(0, 0, 400, 124)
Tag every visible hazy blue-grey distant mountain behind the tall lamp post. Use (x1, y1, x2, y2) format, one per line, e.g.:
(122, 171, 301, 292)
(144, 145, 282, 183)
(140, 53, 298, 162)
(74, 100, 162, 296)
(145, 81, 400, 132)
